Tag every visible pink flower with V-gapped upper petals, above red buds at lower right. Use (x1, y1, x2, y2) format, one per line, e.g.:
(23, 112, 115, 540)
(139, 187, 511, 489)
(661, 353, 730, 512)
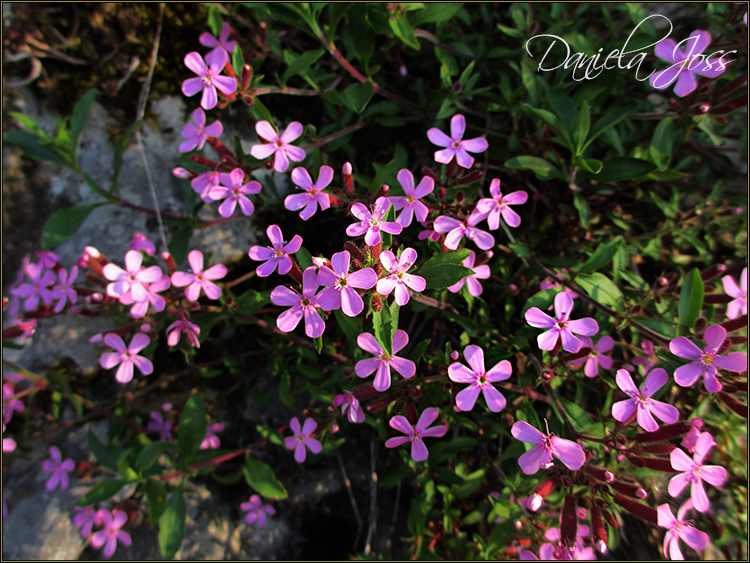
(612, 368, 680, 432)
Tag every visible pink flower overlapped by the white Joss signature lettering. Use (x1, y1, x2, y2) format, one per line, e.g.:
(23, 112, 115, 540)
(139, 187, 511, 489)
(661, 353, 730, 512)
(649, 29, 727, 98)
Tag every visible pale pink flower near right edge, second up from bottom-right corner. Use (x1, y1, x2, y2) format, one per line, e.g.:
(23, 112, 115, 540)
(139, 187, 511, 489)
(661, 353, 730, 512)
(668, 432, 727, 512)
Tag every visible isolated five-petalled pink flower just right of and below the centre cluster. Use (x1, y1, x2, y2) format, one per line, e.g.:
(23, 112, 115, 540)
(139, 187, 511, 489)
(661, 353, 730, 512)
(448, 345, 513, 412)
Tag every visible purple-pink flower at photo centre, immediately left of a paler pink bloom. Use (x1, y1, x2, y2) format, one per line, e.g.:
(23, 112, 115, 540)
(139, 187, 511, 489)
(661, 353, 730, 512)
(318, 250, 378, 317)
